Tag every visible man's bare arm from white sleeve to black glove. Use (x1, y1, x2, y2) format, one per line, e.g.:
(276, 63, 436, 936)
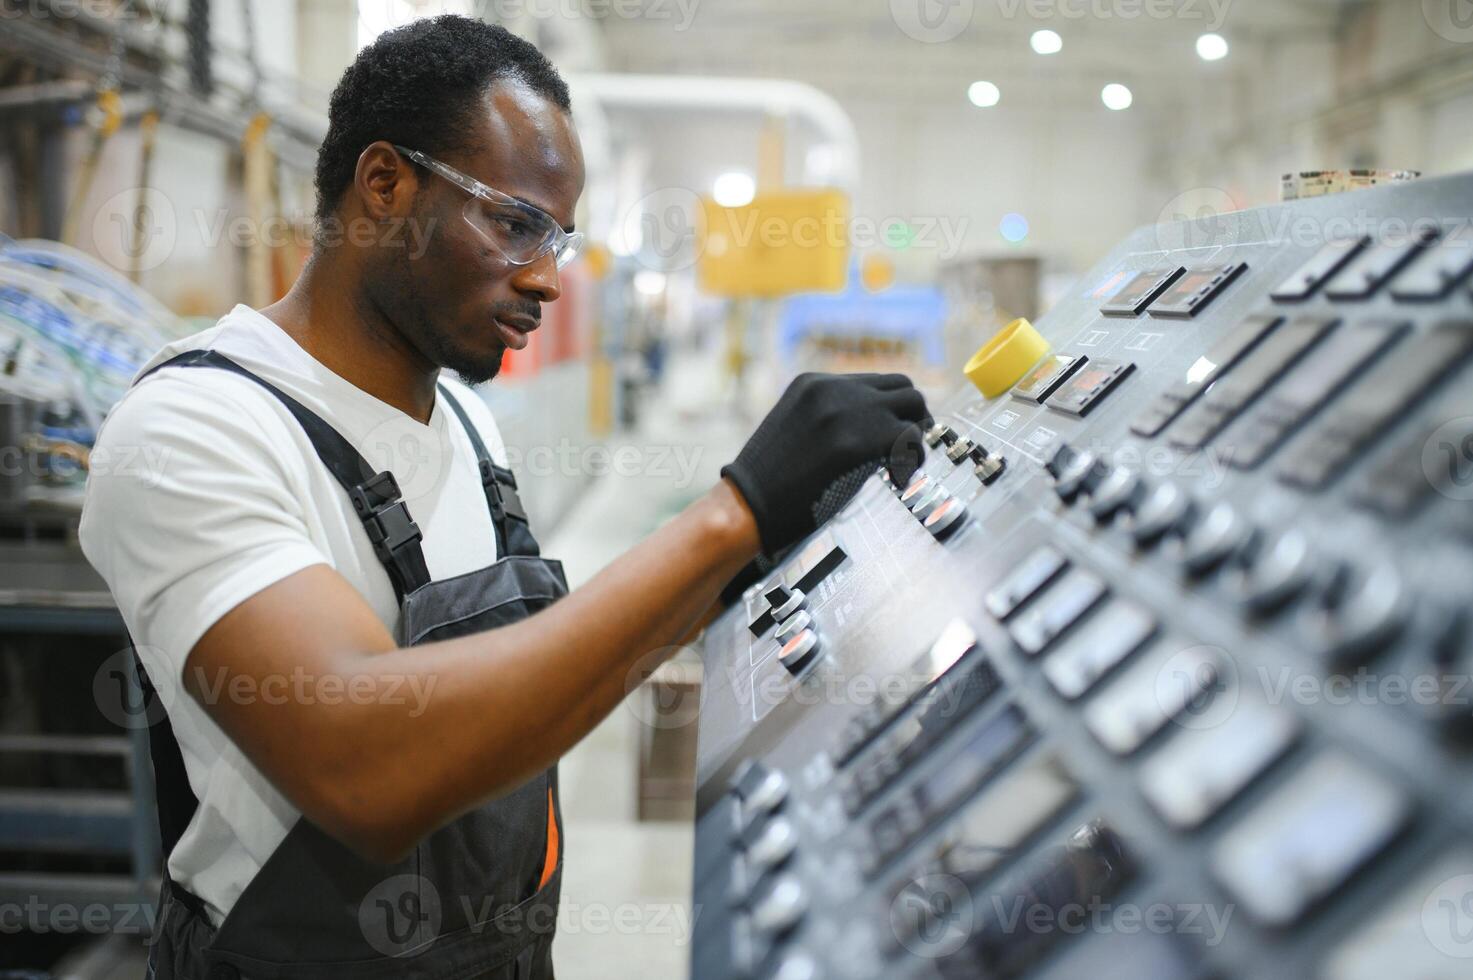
(184, 480, 759, 861)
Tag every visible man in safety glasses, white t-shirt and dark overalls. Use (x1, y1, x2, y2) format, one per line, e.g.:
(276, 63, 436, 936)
(81, 16, 925, 980)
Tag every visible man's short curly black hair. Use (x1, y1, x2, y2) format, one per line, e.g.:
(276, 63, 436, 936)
(317, 13, 572, 223)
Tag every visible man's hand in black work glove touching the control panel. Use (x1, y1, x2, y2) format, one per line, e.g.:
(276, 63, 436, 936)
(722, 374, 928, 556)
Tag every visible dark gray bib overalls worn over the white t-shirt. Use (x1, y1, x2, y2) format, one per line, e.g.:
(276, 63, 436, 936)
(138, 351, 567, 980)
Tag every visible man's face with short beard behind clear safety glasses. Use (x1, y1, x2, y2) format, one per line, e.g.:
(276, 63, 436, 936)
(364, 80, 583, 385)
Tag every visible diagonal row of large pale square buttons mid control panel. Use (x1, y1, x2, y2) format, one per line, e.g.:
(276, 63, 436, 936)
(987, 547, 1410, 925)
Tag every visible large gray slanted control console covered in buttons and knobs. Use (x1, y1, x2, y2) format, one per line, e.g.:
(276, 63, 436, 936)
(691, 175, 1473, 980)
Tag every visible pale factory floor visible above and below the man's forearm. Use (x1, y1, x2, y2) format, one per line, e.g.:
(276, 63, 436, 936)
(544, 349, 750, 980)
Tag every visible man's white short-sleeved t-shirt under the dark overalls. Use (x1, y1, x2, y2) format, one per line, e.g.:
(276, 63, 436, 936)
(80, 307, 505, 924)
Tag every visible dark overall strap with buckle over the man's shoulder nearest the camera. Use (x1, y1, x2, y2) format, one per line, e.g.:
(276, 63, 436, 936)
(134, 351, 430, 603)
